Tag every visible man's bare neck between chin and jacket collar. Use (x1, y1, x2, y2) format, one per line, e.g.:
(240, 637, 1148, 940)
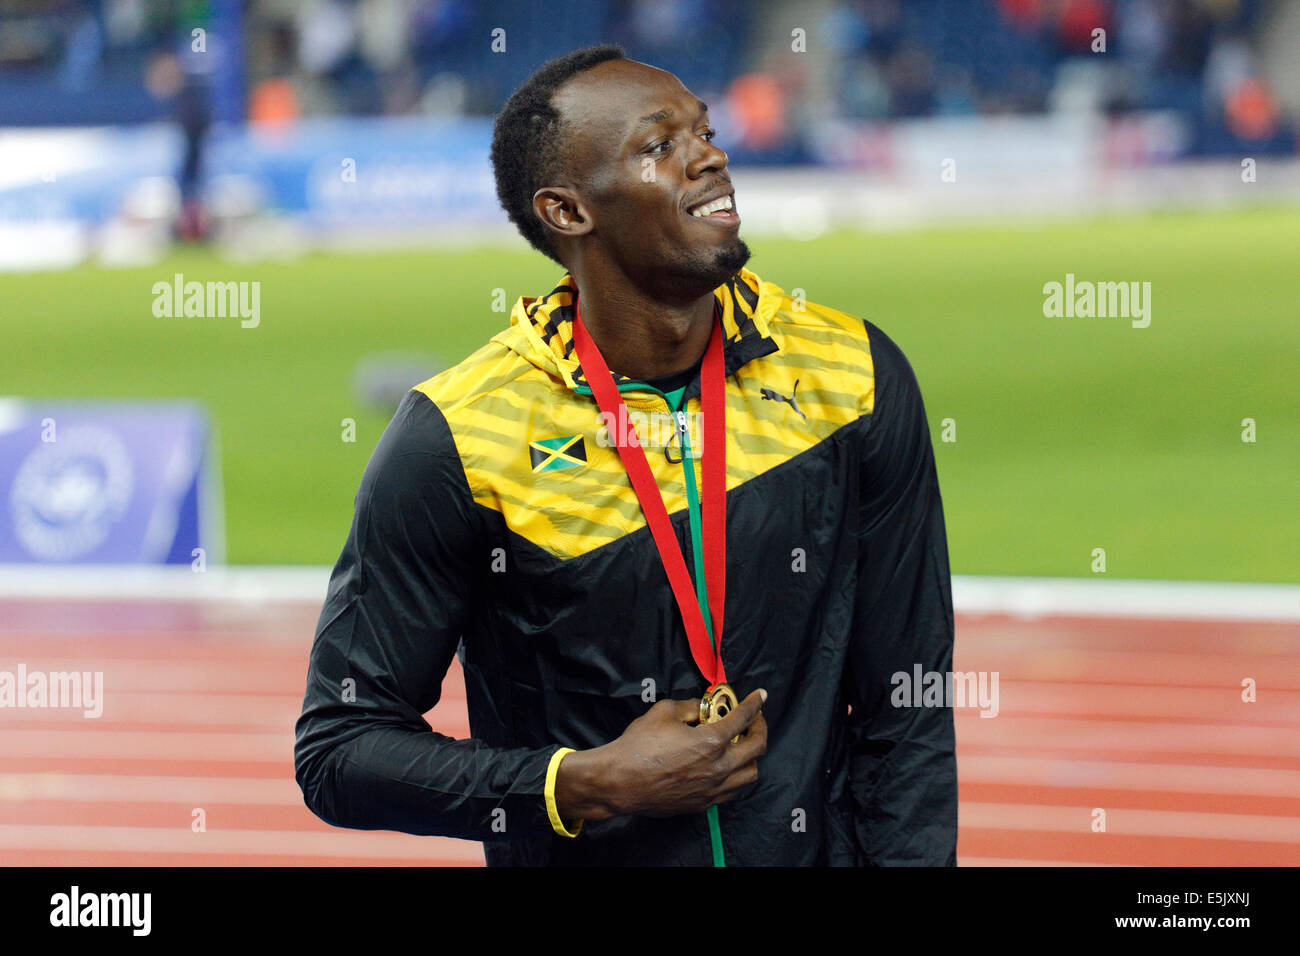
(573, 264, 715, 380)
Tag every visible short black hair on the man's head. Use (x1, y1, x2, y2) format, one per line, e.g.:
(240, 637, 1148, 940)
(491, 43, 627, 265)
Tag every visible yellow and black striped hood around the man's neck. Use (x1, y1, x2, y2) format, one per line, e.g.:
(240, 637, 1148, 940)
(493, 268, 784, 397)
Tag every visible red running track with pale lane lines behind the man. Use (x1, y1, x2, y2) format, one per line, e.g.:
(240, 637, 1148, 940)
(0, 601, 1300, 866)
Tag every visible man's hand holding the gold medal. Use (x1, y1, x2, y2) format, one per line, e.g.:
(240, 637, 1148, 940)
(555, 691, 767, 819)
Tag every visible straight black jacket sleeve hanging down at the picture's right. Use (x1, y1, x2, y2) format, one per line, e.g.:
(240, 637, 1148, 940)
(845, 323, 957, 866)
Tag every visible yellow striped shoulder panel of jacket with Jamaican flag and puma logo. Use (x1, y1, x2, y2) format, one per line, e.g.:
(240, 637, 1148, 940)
(416, 291, 875, 559)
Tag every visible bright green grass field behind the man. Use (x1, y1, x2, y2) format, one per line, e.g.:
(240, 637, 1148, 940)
(0, 209, 1300, 581)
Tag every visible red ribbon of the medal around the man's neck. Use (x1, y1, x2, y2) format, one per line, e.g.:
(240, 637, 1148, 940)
(573, 293, 727, 691)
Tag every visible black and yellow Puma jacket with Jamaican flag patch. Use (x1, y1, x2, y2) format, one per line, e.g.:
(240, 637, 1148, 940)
(295, 269, 957, 865)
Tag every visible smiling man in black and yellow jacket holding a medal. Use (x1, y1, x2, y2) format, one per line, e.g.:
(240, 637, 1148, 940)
(295, 46, 957, 865)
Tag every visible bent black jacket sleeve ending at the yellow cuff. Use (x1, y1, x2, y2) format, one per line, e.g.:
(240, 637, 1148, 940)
(294, 392, 560, 840)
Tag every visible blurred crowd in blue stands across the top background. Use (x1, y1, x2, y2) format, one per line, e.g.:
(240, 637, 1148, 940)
(0, 0, 1300, 163)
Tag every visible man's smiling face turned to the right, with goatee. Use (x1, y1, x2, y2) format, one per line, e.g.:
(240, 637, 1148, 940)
(533, 60, 750, 300)
